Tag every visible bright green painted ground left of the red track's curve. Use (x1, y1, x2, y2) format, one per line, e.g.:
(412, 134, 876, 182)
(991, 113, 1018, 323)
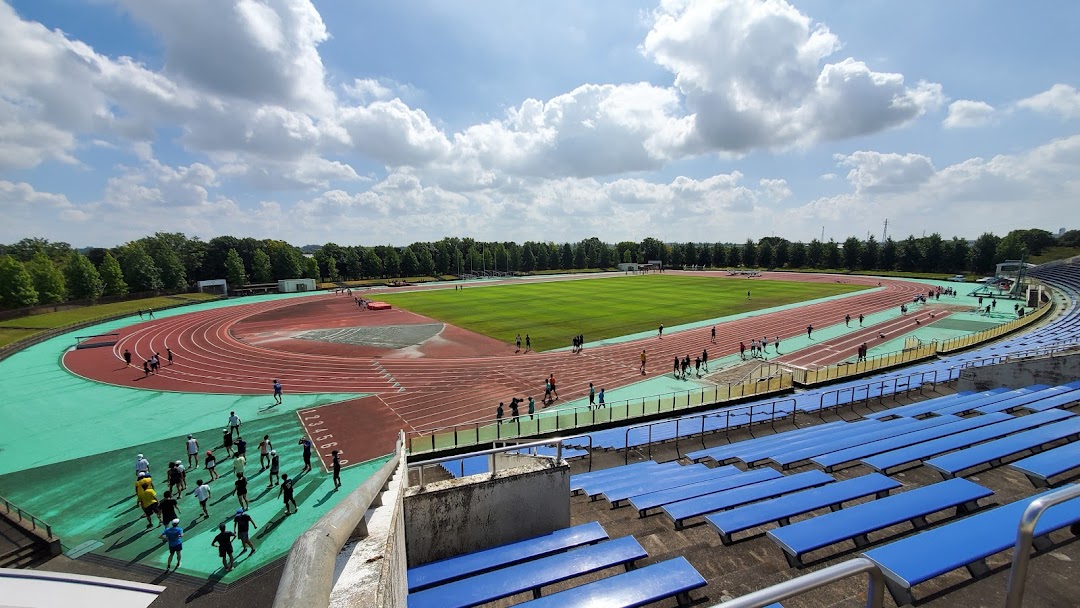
(0, 294, 386, 582)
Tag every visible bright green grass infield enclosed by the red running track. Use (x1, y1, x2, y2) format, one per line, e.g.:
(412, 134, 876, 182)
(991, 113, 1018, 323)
(379, 274, 866, 350)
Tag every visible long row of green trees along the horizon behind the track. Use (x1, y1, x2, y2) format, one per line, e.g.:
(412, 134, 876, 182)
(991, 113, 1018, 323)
(0, 229, 1080, 308)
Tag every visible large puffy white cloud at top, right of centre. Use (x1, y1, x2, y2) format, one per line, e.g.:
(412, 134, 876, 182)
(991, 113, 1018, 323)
(642, 0, 943, 153)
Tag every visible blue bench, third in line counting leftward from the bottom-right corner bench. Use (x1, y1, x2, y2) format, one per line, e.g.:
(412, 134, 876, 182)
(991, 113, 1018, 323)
(705, 473, 901, 544)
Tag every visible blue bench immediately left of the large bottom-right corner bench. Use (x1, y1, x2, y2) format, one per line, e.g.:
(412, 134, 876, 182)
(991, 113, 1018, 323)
(768, 479, 994, 568)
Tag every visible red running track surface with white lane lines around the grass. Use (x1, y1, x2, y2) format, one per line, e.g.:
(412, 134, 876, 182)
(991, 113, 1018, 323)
(65, 273, 927, 456)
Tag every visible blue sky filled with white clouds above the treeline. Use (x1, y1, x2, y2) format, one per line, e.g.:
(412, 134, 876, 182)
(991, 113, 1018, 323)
(0, 0, 1080, 246)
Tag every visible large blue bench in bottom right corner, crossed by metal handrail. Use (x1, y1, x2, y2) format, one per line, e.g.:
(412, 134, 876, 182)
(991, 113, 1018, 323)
(863, 479, 1080, 606)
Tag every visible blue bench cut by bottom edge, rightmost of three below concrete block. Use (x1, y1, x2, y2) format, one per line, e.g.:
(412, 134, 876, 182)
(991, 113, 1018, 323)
(518, 557, 707, 608)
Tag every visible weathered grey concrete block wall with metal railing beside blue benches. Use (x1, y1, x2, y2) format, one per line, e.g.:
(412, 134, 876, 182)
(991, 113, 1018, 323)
(405, 455, 570, 568)
